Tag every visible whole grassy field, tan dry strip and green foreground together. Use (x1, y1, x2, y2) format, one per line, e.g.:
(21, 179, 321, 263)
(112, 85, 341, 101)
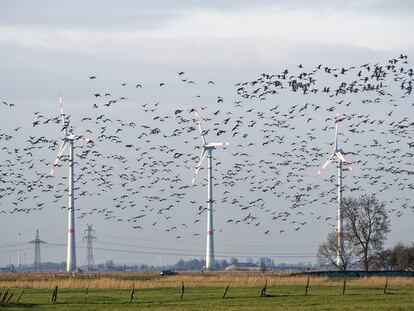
(0, 274, 414, 311)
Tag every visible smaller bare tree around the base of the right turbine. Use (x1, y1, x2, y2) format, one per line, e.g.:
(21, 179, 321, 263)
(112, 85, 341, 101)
(316, 232, 355, 271)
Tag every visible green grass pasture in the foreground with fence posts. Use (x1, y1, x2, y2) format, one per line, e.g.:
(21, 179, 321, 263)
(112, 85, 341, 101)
(0, 285, 414, 311)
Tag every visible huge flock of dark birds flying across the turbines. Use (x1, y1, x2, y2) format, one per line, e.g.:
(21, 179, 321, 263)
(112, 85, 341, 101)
(0, 55, 414, 243)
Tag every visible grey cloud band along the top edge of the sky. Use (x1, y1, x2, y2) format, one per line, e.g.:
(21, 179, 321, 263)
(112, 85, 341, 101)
(0, 0, 414, 30)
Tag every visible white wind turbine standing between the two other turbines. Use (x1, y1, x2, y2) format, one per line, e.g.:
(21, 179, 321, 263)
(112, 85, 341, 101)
(191, 110, 230, 270)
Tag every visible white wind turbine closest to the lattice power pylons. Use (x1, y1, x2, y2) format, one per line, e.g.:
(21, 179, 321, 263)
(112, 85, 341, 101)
(49, 96, 91, 272)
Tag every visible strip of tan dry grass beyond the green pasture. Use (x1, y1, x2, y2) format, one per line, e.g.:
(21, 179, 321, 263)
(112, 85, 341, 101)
(0, 272, 414, 289)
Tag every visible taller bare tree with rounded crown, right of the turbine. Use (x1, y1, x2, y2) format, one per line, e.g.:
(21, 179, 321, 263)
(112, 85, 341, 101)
(342, 195, 390, 271)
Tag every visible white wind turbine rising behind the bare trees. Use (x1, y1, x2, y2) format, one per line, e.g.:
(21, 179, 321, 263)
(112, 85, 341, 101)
(316, 114, 352, 267)
